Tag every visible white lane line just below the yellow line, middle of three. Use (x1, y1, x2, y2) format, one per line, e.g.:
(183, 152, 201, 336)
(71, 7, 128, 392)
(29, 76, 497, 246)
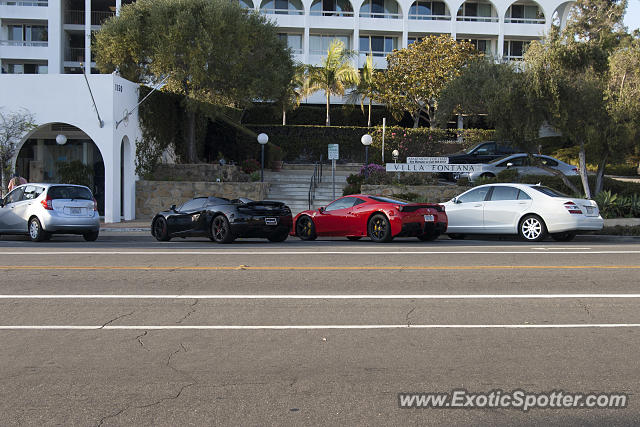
(0, 294, 640, 300)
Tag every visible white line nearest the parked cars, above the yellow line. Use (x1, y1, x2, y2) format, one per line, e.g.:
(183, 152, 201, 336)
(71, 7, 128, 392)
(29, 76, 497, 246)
(0, 248, 640, 256)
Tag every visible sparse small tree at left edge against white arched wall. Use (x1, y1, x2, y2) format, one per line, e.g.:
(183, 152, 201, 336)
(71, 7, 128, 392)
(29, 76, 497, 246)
(0, 110, 36, 196)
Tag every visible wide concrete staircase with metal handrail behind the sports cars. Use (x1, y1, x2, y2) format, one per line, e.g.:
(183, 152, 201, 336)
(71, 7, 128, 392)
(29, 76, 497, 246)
(264, 164, 361, 216)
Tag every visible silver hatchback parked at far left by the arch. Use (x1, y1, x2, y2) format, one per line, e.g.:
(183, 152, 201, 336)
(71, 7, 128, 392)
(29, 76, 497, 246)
(0, 183, 100, 242)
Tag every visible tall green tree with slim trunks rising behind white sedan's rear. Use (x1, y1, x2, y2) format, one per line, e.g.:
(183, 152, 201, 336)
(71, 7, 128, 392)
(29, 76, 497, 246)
(525, 0, 629, 198)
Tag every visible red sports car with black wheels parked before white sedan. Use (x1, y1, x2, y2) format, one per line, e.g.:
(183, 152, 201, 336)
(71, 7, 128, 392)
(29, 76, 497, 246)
(291, 194, 447, 243)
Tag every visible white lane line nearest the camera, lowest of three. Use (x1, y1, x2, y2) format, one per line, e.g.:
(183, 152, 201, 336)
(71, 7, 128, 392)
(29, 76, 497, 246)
(0, 323, 640, 330)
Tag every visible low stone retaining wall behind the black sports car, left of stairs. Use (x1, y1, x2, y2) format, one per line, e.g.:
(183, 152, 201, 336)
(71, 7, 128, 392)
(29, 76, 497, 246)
(136, 181, 269, 220)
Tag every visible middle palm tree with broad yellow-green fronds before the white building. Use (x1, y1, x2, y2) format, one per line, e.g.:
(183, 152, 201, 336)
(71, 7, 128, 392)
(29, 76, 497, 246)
(309, 39, 360, 126)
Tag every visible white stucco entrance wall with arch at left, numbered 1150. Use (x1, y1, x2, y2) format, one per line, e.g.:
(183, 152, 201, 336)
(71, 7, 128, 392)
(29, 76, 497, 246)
(0, 74, 141, 222)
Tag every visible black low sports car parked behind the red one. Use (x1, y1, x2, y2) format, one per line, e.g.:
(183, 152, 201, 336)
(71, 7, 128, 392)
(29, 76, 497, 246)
(151, 197, 292, 243)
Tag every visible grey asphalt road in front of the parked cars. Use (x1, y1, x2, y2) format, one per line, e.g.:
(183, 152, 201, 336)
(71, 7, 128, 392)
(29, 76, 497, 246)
(0, 233, 640, 426)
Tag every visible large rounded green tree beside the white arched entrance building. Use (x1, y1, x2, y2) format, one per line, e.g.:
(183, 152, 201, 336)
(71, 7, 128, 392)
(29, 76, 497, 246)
(95, 0, 293, 162)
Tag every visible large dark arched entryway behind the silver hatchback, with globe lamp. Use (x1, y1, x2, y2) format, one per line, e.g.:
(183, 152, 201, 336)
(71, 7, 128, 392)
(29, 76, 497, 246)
(15, 123, 105, 215)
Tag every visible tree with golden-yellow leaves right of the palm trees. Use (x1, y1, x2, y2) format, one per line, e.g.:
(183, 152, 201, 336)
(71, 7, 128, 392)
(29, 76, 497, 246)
(374, 35, 475, 128)
